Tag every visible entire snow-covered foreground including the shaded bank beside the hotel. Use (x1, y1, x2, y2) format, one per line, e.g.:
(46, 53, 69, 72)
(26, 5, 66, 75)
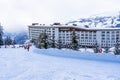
(0, 47, 120, 80)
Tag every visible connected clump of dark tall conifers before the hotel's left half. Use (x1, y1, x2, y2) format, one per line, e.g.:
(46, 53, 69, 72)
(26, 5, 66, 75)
(31, 31, 79, 50)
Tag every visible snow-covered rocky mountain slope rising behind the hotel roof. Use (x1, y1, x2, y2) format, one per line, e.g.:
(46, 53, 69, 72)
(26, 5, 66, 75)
(67, 12, 120, 28)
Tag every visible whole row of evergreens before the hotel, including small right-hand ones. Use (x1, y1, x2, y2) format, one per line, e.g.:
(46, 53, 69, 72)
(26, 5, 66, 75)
(31, 31, 120, 55)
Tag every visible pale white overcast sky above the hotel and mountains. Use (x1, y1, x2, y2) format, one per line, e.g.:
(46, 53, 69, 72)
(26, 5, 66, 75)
(0, 0, 120, 31)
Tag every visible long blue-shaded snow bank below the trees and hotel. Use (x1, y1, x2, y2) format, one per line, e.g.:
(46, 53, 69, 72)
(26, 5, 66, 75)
(33, 48, 120, 63)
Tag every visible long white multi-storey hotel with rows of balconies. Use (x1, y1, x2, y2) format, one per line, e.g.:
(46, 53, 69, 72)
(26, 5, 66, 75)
(28, 23, 120, 47)
